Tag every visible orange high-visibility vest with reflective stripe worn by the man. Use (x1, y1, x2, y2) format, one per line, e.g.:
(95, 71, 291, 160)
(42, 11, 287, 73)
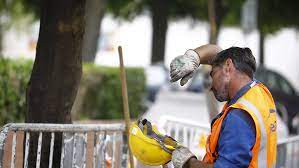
(203, 82, 277, 168)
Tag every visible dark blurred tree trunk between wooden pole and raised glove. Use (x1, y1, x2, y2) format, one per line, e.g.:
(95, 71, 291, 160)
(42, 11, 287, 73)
(151, 0, 169, 64)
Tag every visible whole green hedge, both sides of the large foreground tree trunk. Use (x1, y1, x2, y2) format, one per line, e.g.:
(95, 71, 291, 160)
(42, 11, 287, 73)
(0, 57, 145, 125)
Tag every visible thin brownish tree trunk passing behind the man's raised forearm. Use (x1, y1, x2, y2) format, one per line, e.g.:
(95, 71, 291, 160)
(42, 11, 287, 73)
(204, 0, 224, 121)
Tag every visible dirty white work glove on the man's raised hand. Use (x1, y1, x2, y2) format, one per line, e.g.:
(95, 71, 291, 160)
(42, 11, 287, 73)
(170, 50, 200, 86)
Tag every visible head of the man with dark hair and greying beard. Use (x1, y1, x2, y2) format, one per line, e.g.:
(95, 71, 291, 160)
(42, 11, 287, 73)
(210, 47, 256, 102)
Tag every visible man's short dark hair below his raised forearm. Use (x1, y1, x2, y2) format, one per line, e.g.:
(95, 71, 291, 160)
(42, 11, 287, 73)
(212, 47, 256, 78)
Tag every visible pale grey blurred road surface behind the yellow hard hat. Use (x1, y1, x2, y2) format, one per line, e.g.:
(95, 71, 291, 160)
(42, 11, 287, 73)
(144, 89, 209, 124)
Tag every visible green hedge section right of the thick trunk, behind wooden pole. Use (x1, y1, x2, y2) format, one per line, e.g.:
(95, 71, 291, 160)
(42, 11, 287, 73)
(73, 64, 145, 119)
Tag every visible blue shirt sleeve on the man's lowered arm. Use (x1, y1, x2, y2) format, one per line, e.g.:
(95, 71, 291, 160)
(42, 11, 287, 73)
(214, 109, 255, 168)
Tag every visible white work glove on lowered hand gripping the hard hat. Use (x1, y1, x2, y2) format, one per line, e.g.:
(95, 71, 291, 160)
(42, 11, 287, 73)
(171, 146, 196, 168)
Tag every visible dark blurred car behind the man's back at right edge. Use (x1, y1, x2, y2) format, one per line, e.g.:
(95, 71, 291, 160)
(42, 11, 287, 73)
(255, 67, 299, 134)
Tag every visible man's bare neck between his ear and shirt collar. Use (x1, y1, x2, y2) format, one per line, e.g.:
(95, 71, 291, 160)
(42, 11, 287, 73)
(229, 74, 252, 99)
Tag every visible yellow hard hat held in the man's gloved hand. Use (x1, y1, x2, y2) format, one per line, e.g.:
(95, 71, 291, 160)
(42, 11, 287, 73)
(129, 119, 177, 166)
